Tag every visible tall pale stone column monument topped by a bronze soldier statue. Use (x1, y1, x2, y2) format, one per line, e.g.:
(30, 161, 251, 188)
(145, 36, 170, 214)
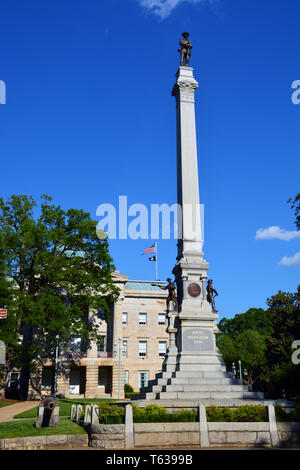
(135, 32, 263, 404)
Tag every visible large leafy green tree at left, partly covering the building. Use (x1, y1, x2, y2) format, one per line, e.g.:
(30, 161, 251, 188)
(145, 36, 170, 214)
(0, 195, 118, 394)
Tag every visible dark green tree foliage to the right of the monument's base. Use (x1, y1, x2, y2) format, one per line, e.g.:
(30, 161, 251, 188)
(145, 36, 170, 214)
(217, 286, 300, 398)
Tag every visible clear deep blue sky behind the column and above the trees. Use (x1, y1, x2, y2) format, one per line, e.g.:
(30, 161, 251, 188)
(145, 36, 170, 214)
(0, 0, 300, 318)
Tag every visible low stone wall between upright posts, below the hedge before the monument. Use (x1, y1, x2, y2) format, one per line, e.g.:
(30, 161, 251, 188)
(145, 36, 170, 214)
(89, 422, 300, 449)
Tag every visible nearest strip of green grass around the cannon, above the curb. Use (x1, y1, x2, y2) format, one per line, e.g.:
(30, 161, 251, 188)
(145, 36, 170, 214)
(0, 418, 86, 439)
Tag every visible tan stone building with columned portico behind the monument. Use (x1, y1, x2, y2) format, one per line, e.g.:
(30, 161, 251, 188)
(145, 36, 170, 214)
(7, 272, 168, 399)
